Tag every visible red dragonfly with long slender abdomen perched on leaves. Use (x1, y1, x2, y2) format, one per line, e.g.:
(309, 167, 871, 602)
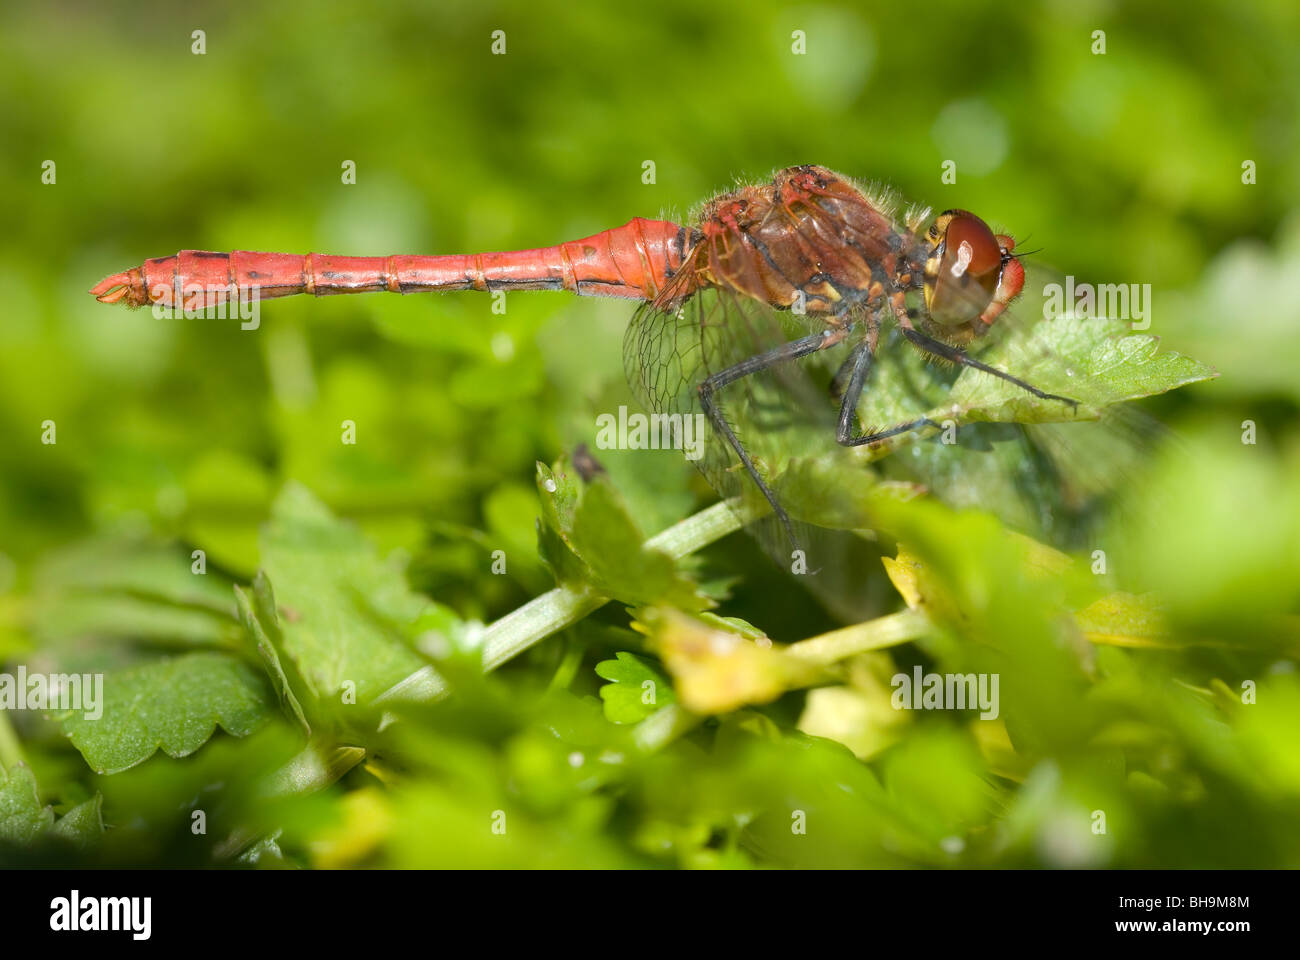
(91, 165, 1078, 572)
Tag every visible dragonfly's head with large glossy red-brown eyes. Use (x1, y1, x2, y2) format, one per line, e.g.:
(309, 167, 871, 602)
(924, 209, 1024, 341)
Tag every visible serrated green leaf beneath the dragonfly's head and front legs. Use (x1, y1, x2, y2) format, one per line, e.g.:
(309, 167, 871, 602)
(821, 307, 1217, 544)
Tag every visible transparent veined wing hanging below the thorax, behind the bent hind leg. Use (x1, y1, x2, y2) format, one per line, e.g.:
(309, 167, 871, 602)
(624, 277, 899, 618)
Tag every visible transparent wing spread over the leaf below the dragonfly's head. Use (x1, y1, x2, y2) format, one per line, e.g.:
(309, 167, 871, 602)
(858, 257, 1195, 549)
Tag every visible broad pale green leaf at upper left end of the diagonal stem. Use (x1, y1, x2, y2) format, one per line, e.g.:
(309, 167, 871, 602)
(261, 483, 430, 702)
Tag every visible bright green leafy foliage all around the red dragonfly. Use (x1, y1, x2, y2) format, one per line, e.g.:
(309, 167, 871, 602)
(0, 0, 1300, 869)
